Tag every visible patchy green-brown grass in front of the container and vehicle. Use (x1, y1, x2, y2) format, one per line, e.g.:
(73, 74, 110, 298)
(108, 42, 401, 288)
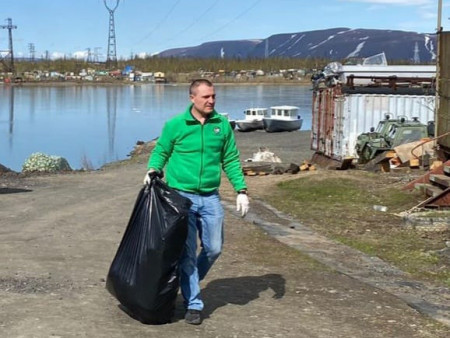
(264, 171, 450, 286)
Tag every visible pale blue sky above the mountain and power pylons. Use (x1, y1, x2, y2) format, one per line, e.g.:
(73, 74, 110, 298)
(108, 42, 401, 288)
(0, 0, 450, 61)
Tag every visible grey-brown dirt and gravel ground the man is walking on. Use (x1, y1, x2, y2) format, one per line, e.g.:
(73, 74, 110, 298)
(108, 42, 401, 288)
(0, 133, 449, 337)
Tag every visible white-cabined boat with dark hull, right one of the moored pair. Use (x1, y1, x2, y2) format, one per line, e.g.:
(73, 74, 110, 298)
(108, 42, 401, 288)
(263, 106, 303, 133)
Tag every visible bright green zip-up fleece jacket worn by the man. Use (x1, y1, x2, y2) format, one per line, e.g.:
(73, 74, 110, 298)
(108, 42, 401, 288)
(148, 105, 247, 194)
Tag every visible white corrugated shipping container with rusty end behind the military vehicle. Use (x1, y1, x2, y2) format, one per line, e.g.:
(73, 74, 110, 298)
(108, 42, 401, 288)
(311, 87, 435, 161)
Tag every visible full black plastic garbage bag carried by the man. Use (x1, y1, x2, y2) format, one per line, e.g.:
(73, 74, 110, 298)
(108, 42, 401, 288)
(106, 177, 191, 324)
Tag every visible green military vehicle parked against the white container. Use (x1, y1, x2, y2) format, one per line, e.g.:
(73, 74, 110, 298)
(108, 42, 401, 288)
(355, 116, 434, 164)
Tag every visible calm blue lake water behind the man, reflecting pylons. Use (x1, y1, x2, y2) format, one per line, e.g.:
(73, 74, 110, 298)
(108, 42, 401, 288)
(0, 84, 312, 171)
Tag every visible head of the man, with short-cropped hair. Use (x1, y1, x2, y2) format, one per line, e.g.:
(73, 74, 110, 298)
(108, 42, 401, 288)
(189, 79, 216, 116)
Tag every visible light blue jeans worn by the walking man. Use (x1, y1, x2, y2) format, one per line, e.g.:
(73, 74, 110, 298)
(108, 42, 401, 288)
(179, 191, 224, 310)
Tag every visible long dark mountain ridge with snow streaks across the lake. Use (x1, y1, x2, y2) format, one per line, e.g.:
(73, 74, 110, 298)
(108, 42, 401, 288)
(158, 27, 437, 63)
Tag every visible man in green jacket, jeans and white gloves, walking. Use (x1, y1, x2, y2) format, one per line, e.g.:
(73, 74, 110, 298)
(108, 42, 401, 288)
(144, 79, 249, 325)
